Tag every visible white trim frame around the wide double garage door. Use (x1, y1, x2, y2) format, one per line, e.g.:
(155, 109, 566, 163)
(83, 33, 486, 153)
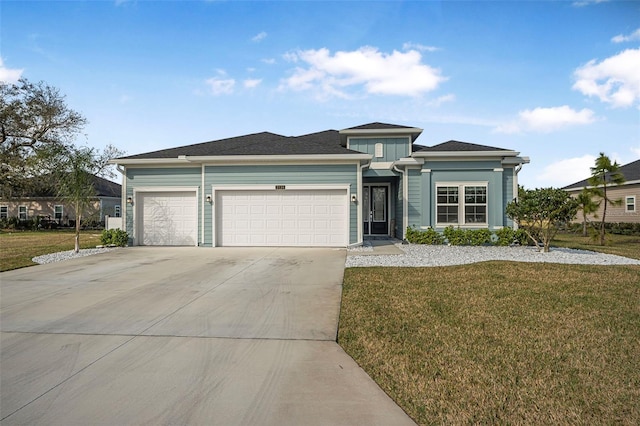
(211, 184, 351, 247)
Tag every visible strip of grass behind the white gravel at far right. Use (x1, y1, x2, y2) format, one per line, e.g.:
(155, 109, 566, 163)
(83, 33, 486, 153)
(552, 233, 640, 259)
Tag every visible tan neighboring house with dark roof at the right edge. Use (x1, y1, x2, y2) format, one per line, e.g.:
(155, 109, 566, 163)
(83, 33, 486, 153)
(562, 160, 640, 223)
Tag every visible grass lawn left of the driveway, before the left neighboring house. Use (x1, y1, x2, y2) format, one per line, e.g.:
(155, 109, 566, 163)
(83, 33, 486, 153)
(0, 230, 100, 271)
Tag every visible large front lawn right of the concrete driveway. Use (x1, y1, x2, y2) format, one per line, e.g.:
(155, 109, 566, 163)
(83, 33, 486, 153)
(338, 262, 640, 425)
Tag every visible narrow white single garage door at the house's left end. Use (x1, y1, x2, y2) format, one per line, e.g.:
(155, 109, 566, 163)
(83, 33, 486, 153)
(137, 191, 198, 246)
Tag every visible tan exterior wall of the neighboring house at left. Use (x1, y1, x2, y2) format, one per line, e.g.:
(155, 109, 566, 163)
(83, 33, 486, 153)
(0, 197, 110, 226)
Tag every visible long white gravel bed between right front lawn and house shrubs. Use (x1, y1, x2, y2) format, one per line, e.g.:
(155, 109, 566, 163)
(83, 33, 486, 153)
(345, 244, 640, 268)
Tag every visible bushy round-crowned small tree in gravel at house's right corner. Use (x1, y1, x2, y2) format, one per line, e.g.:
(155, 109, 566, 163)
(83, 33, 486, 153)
(507, 188, 578, 253)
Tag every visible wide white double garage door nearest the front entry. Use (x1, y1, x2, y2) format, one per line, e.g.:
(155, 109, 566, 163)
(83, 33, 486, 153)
(216, 189, 349, 247)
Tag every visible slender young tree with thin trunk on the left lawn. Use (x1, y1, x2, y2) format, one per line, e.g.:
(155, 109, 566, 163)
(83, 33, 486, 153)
(56, 145, 123, 253)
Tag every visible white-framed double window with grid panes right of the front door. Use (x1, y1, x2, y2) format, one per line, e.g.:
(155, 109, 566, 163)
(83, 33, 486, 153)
(436, 182, 488, 225)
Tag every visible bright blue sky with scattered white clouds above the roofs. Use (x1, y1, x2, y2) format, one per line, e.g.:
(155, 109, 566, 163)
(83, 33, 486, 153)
(0, 0, 640, 188)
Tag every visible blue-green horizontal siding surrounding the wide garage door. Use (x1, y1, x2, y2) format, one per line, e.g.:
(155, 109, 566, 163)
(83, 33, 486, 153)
(204, 164, 360, 246)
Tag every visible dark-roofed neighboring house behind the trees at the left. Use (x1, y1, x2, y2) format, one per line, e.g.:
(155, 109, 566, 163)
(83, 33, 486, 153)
(0, 176, 122, 226)
